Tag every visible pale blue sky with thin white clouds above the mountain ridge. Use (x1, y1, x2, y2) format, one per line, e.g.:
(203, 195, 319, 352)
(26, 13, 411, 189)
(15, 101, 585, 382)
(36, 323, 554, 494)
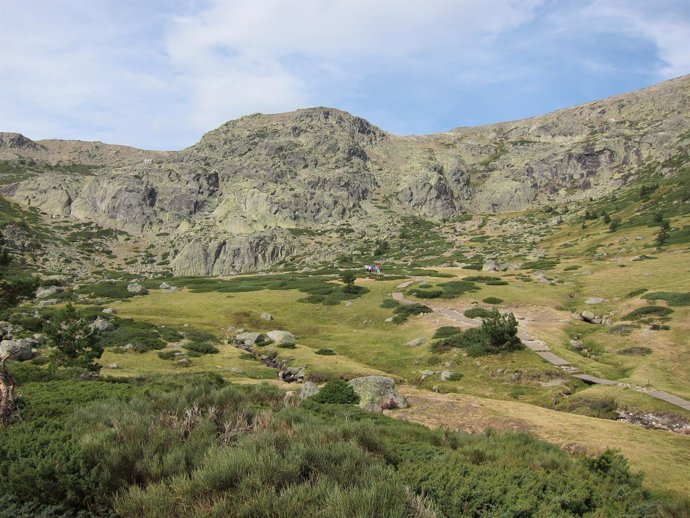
(0, 0, 690, 150)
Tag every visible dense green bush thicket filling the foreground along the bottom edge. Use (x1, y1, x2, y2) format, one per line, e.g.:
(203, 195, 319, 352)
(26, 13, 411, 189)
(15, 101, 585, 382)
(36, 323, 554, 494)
(0, 367, 680, 518)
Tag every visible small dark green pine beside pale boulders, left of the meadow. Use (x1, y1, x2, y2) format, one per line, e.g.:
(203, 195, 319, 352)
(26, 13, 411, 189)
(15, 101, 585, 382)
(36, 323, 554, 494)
(45, 304, 103, 372)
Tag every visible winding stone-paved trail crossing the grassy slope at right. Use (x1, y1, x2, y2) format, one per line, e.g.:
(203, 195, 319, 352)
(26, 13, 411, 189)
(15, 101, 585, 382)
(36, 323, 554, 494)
(392, 281, 690, 412)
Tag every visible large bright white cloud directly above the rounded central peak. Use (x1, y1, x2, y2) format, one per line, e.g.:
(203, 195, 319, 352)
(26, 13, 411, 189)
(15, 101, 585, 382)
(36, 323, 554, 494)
(167, 0, 542, 129)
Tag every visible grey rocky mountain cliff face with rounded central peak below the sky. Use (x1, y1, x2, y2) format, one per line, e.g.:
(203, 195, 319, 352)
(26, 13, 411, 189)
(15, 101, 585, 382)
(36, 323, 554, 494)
(0, 76, 690, 275)
